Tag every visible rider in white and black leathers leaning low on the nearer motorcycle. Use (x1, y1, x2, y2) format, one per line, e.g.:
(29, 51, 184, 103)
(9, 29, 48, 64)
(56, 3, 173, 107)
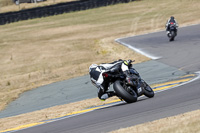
(89, 59, 132, 101)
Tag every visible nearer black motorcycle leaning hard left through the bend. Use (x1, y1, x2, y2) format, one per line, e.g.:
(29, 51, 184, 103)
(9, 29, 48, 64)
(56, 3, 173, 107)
(102, 60, 154, 103)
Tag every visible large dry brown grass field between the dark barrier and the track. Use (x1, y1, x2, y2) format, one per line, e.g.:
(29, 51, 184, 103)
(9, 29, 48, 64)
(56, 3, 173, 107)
(0, 0, 200, 131)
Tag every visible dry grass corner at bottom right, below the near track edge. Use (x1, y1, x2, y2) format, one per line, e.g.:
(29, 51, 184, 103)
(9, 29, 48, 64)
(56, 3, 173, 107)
(109, 110, 200, 133)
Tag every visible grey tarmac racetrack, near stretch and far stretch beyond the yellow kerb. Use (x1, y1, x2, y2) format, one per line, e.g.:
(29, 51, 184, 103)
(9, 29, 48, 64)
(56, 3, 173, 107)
(14, 25, 200, 133)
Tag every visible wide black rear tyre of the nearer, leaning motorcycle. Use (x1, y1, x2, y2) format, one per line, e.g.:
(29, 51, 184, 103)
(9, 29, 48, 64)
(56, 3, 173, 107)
(113, 80, 137, 103)
